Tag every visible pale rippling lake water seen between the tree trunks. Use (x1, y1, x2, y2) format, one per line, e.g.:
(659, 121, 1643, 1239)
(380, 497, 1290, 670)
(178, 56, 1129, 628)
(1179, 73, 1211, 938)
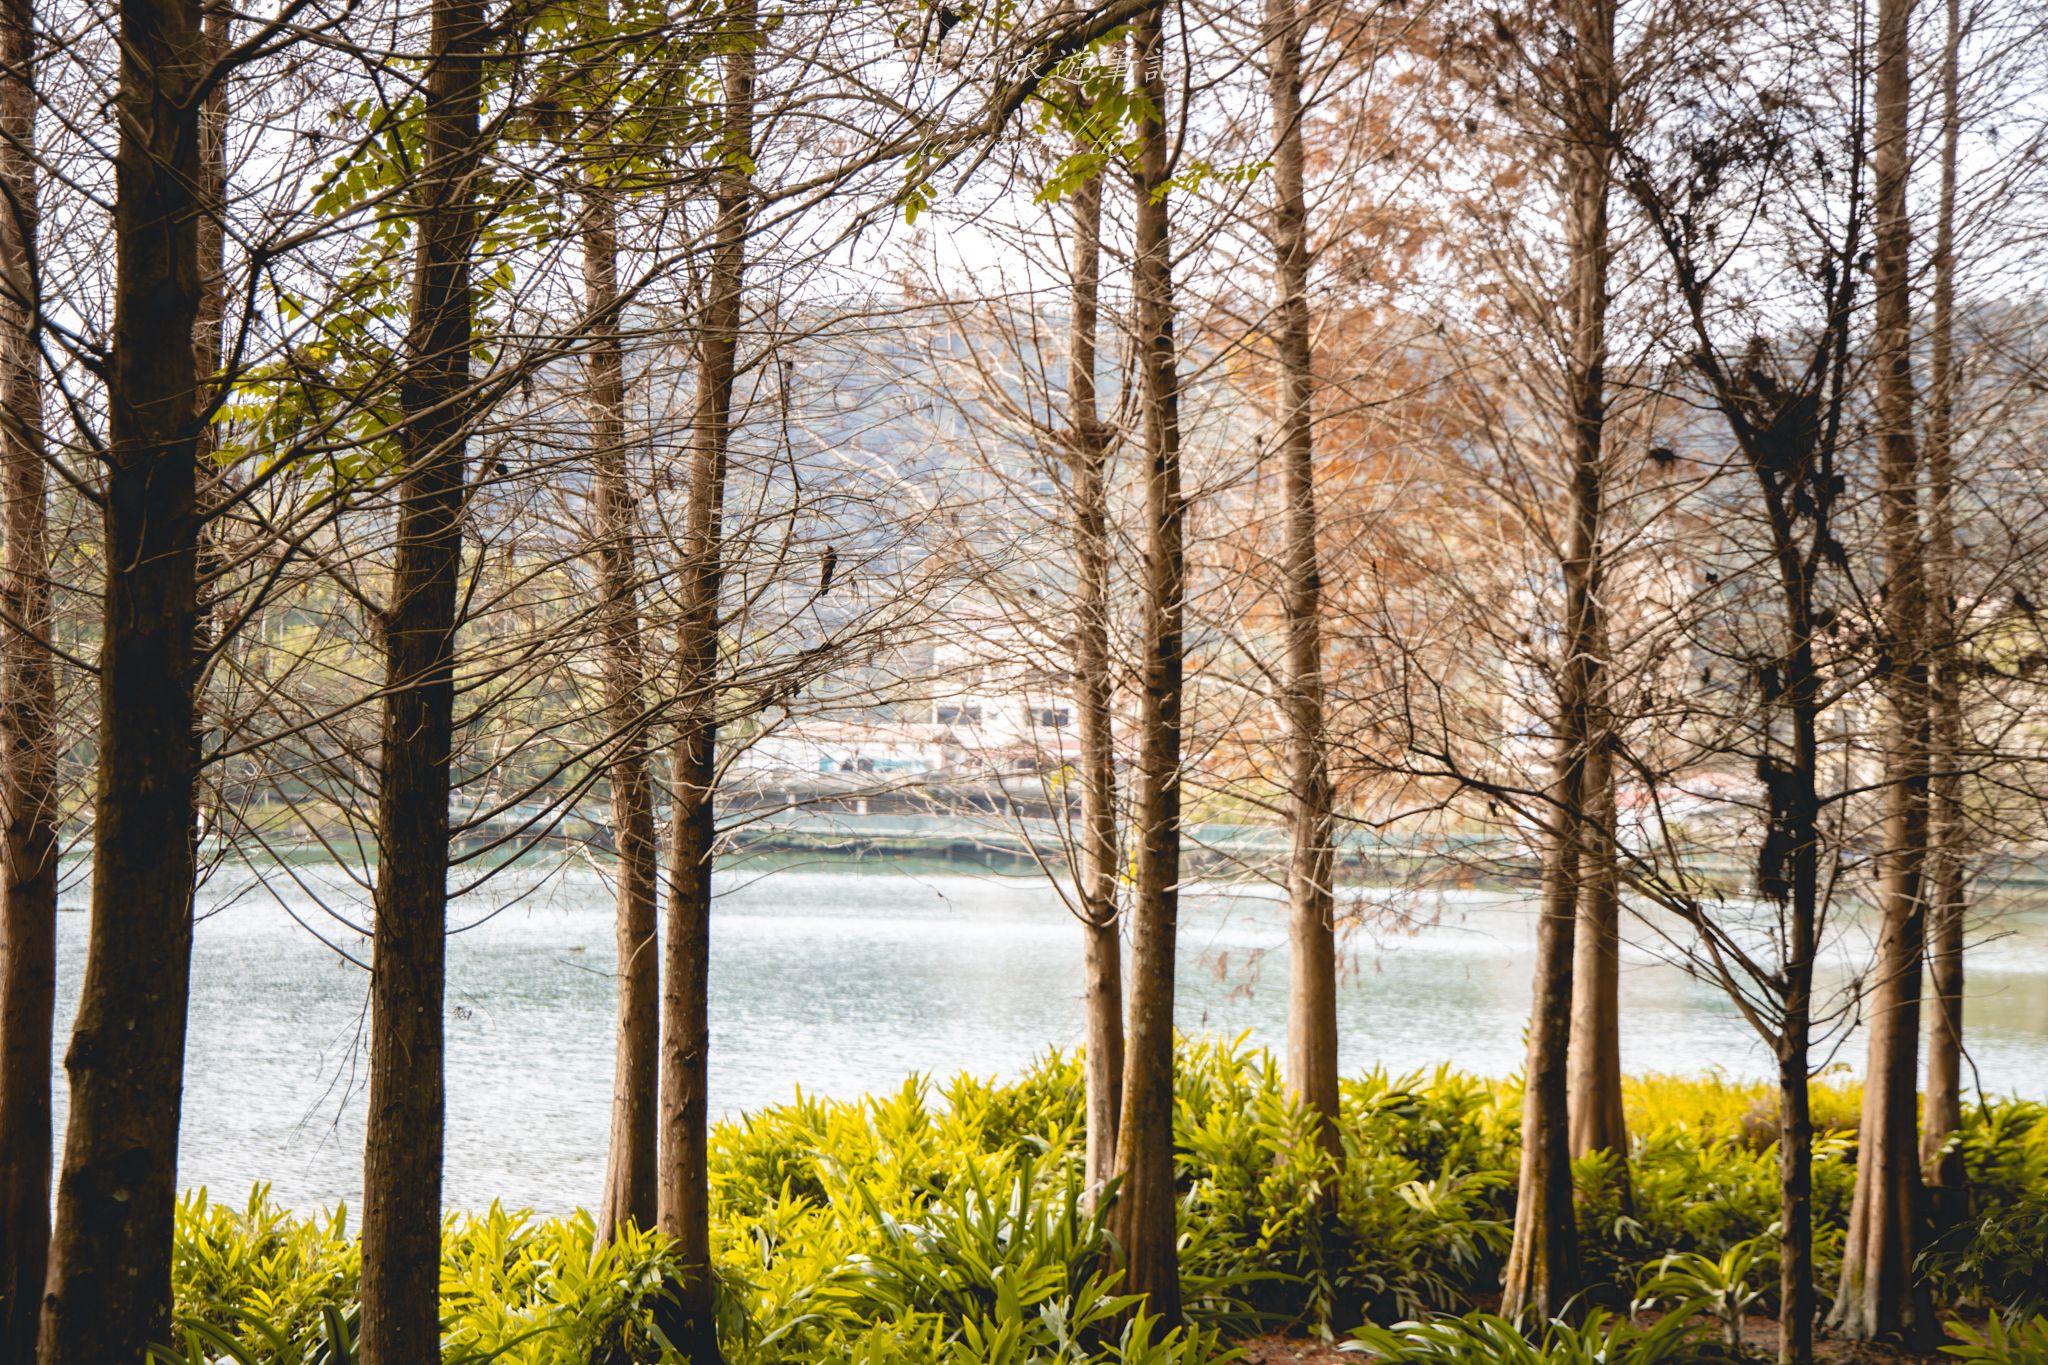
(44, 864, 2048, 1212)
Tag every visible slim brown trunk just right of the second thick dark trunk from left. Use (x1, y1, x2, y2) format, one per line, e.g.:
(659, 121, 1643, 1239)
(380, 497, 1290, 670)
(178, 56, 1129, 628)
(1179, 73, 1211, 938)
(582, 182, 662, 1236)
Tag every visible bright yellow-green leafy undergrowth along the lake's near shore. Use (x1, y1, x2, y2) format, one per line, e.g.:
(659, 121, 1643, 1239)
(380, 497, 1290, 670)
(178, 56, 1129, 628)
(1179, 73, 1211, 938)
(162, 1040, 2048, 1365)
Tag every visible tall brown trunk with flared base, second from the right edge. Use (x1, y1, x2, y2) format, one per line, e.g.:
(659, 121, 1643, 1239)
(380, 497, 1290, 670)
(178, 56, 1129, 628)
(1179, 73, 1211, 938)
(1831, 0, 1933, 1345)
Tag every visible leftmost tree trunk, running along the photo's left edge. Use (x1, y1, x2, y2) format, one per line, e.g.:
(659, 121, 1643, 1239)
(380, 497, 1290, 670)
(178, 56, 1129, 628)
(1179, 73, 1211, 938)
(0, 0, 57, 1365)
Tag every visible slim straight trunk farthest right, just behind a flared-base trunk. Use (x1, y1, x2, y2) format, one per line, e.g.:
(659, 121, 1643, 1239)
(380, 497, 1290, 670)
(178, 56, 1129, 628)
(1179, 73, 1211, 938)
(1921, 0, 1968, 1226)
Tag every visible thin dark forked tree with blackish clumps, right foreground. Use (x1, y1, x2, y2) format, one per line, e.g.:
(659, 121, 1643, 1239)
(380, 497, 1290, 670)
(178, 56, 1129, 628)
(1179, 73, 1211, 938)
(1624, 13, 1866, 1342)
